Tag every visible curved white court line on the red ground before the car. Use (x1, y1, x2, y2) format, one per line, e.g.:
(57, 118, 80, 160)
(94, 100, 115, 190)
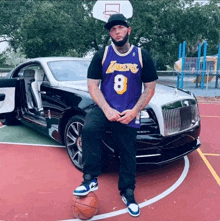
(62, 156, 189, 221)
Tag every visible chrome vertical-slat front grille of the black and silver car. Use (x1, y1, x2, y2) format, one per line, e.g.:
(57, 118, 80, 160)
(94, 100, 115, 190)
(162, 103, 199, 135)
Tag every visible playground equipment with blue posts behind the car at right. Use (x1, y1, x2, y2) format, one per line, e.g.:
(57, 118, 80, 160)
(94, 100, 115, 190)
(174, 41, 220, 89)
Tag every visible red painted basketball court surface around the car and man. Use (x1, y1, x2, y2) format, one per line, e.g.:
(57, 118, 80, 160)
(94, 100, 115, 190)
(0, 104, 220, 221)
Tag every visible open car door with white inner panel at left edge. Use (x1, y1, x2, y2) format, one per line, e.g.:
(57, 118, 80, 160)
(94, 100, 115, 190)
(0, 78, 19, 124)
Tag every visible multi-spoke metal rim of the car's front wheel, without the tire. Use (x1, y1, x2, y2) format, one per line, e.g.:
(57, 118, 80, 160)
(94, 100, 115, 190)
(66, 122, 83, 169)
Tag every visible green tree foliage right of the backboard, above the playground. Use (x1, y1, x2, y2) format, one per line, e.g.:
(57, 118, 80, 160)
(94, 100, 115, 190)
(132, 0, 220, 67)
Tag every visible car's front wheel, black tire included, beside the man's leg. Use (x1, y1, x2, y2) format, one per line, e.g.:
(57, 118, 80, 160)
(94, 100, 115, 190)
(64, 116, 84, 170)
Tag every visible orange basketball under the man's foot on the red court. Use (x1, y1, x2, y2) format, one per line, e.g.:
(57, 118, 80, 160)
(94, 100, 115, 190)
(73, 192, 98, 220)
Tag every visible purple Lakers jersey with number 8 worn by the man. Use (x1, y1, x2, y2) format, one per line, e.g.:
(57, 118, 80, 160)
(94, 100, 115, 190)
(101, 45, 142, 128)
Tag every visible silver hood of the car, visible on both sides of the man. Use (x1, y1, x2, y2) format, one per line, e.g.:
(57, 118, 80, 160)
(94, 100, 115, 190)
(59, 81, 194, 106)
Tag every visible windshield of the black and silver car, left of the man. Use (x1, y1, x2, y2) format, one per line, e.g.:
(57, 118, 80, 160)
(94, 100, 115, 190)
(48, 60, 90, 81)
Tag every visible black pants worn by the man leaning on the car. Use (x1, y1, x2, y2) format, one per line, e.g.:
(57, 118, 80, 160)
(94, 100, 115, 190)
(82, 106, 137, 192)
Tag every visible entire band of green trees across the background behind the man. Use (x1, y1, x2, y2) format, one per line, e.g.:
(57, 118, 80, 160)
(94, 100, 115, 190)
(0, 0, 220, 69)
